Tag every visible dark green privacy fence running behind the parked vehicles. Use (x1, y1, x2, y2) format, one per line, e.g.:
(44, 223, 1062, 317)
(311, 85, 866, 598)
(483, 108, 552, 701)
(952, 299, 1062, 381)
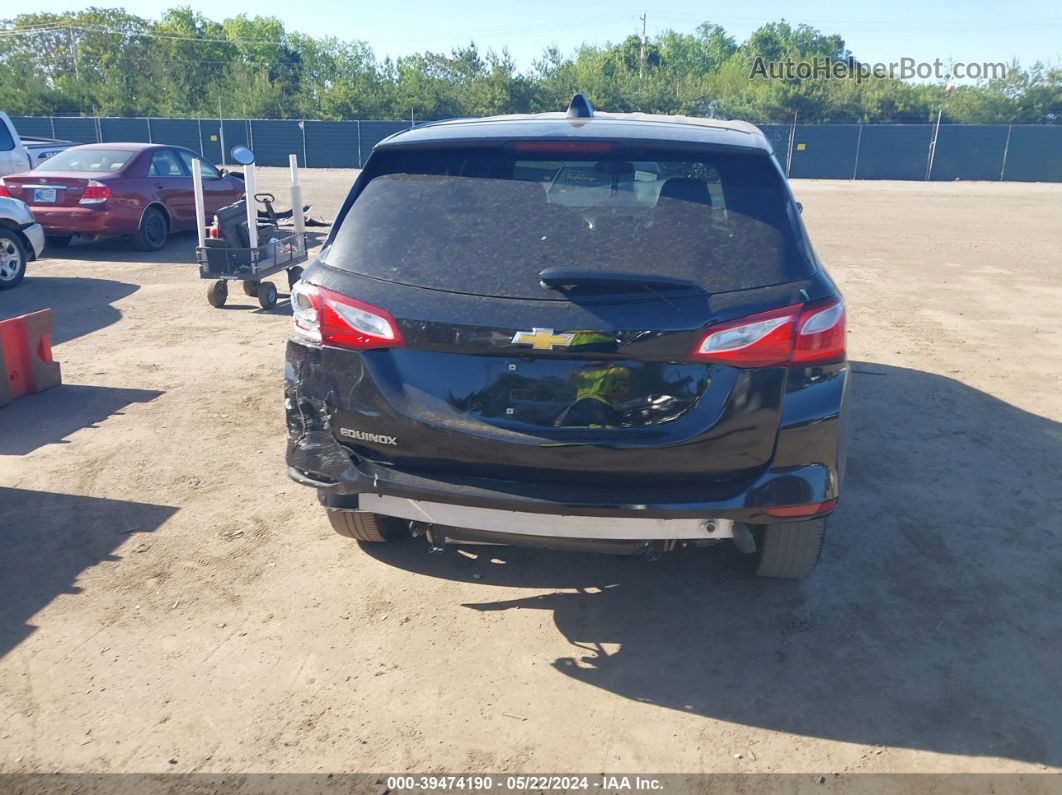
(13, 116, 1062, 183)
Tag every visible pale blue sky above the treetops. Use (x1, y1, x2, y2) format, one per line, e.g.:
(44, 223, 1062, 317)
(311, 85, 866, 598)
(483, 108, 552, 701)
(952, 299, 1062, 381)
(24, 0, 1062, 68)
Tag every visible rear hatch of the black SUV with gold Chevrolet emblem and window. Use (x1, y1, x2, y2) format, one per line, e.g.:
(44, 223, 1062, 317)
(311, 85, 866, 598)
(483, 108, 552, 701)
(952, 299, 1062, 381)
(304, 141, 811, 482)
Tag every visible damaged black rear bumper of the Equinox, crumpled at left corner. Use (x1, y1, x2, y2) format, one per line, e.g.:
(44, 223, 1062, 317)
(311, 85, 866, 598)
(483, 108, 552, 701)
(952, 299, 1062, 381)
(285, 341, 850, 523)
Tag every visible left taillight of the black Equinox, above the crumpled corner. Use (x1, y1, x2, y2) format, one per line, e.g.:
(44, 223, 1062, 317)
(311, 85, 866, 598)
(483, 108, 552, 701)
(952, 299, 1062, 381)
(291, 281, 402, 350)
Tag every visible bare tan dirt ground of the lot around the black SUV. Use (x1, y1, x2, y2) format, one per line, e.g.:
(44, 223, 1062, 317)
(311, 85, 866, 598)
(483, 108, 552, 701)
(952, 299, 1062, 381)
(0, 170, 1062, 773)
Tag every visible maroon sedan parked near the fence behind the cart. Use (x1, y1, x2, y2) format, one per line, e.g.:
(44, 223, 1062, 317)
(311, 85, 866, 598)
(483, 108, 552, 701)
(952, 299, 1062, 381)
(0, 143, 243, 252)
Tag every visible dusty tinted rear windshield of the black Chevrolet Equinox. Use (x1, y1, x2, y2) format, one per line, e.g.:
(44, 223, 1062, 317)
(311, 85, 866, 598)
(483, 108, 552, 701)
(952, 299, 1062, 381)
(327, 149, 808, 298)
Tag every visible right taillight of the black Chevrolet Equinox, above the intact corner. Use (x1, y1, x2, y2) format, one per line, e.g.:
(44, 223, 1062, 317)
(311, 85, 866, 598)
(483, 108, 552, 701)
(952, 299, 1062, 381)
(693, 300, 844, 367)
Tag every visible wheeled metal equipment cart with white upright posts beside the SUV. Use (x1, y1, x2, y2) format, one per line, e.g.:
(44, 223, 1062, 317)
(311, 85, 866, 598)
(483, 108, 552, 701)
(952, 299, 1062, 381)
(192, 146, 307, 309)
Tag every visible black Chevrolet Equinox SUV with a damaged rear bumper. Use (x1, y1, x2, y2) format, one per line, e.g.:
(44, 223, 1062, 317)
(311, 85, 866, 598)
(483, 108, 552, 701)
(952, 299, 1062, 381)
(286, 96, 849, 577)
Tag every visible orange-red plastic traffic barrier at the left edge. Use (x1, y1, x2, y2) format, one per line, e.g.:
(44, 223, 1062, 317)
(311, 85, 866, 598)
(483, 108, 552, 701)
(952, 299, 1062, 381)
(0, 309, 63, 405)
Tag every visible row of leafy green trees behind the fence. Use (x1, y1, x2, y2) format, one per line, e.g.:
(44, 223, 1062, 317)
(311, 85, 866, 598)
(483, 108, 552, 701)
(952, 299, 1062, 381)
(0, 6, 1062, 123)
